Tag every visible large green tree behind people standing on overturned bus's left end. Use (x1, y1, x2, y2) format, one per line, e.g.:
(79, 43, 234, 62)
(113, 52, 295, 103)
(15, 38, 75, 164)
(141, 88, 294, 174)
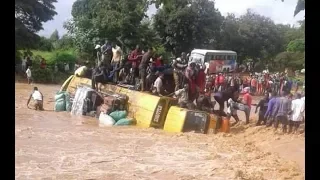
(65, 0, 148, 54)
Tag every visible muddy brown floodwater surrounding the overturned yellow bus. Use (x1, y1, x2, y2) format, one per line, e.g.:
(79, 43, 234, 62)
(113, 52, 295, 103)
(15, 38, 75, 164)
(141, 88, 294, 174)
(15, 83, 305, 180)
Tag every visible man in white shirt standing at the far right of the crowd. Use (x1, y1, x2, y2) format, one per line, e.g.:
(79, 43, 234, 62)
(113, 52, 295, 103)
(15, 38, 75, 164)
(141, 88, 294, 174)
(289, 93, 304, 133)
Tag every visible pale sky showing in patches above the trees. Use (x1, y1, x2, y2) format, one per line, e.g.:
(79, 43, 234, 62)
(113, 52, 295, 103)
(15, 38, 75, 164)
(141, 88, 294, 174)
(38, 0, 305, 37)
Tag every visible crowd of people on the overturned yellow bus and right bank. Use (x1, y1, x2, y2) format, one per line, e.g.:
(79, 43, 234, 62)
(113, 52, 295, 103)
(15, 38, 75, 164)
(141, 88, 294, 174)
(71, 41, 304, 132)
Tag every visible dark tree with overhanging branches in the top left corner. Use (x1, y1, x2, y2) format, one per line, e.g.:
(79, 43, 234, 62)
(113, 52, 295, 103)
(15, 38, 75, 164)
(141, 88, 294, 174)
(15, 0, 57, 49)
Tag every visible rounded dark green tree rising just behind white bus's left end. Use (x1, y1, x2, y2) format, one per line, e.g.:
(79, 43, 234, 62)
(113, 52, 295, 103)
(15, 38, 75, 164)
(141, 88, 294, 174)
(154, 0, 222, 55)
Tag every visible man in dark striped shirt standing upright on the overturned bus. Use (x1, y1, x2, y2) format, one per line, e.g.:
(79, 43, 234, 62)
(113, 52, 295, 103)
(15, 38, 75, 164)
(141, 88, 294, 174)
(172, 52, 188, 91)
